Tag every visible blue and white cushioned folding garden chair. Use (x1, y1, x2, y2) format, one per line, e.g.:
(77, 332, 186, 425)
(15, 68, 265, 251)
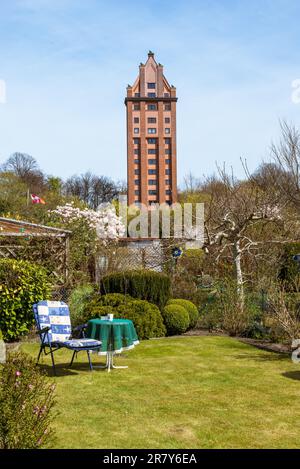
(33, 301, 101, 374)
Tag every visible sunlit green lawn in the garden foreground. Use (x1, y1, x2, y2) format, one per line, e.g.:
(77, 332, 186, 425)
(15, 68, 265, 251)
(23, 337, 300, 448)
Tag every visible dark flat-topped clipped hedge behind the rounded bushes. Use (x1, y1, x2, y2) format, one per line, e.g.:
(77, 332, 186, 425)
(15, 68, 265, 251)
(100, 270, 171, 308)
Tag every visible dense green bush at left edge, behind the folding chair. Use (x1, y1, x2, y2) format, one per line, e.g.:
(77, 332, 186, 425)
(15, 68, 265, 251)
(0, 259, 50, 341)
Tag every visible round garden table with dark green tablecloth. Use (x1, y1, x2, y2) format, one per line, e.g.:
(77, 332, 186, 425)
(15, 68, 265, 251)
(86, 319, 139, 371)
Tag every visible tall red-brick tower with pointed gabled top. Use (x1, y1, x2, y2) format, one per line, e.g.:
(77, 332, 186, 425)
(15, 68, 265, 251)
(125, 51, 177, 205)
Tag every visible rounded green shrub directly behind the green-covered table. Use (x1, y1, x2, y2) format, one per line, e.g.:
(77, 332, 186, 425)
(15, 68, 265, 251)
(81, 293, 166, 339)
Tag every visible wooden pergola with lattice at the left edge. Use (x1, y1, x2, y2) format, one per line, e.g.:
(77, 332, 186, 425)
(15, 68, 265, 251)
(0, 217, 72, 284)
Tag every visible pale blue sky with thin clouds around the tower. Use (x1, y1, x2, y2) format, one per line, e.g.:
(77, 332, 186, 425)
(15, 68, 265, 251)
(0, 0, 300, 186)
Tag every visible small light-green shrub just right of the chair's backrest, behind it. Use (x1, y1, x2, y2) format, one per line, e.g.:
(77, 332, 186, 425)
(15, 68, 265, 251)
(69, 284, 95, 326)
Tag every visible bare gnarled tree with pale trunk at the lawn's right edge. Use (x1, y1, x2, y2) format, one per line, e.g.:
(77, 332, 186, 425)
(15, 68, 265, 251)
(204, 168, 283, 309)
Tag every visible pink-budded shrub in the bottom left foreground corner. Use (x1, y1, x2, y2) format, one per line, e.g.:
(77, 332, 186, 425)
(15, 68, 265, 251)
(0, 352, 55, 449)
